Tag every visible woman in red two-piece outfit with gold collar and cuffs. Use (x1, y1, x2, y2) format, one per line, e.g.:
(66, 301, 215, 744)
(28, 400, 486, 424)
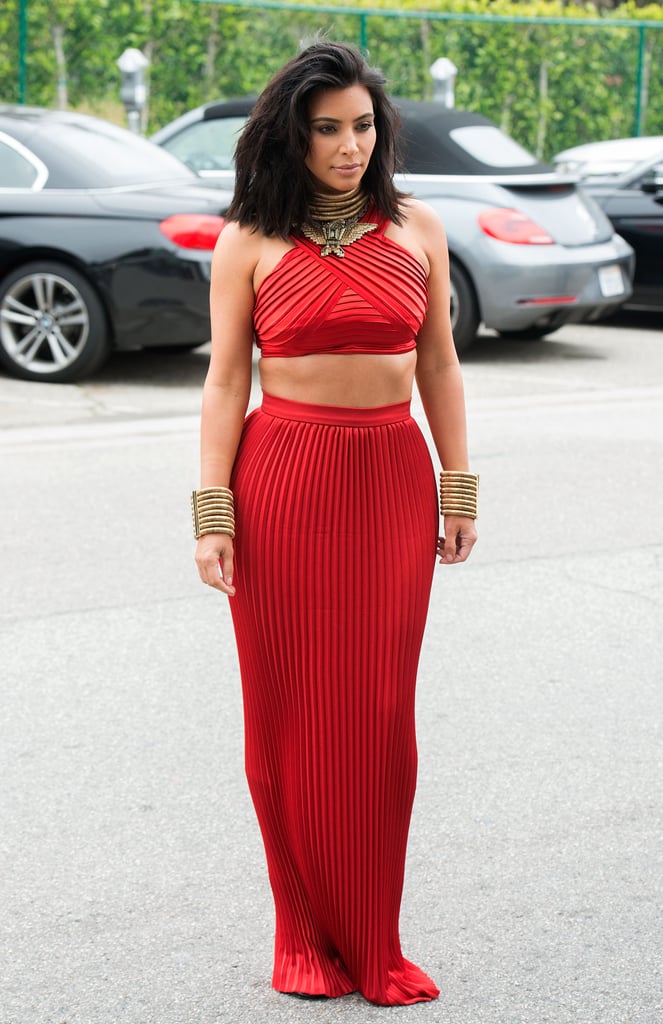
(193, 43, 476, 1005)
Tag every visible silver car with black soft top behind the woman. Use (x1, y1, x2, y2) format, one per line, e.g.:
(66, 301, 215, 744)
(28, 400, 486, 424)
(153, 96, 634, 352)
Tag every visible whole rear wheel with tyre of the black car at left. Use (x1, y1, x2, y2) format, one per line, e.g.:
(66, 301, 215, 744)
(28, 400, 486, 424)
(0, 262, 111, 383)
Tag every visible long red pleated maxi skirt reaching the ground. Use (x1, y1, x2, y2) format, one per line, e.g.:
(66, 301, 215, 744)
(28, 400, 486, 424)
(231, 394, 439, 1005)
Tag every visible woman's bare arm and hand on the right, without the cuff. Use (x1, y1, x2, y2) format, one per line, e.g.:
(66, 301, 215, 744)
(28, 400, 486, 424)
(413, 203, 476, 562)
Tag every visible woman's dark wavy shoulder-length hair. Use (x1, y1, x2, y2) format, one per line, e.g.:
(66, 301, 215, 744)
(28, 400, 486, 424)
(226, 41, 405, 239)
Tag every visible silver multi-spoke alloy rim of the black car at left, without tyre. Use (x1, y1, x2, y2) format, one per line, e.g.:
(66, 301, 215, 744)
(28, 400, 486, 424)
(0, 271, 90, 374)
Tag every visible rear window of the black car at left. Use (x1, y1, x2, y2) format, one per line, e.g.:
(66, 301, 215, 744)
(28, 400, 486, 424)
(28, 120, 193, 188)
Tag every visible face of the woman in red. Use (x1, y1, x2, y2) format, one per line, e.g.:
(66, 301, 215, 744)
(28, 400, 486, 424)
(305, 85, 375, 194)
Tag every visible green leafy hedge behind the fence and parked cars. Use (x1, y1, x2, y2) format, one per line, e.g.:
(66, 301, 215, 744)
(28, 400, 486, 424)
(0, 0, 663, 157)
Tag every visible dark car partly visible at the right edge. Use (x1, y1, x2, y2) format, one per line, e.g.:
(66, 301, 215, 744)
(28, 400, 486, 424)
(583, 151, 663, 311)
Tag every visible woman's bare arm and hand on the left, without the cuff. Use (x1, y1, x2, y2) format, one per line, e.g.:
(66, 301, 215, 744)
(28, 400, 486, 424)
(196, 223, 258, 595)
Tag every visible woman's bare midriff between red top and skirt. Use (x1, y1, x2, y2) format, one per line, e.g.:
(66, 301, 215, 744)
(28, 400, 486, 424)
(258, 349, 417, 409)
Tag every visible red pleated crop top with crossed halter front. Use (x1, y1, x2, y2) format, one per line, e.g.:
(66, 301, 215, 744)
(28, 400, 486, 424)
(253, 210, 428, 357)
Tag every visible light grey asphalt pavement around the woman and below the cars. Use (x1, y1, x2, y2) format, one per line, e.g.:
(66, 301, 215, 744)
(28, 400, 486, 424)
(0, 318, 663, 1024)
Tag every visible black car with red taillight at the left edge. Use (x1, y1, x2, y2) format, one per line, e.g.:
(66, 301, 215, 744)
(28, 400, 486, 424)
(0, 106, 231, 382)
